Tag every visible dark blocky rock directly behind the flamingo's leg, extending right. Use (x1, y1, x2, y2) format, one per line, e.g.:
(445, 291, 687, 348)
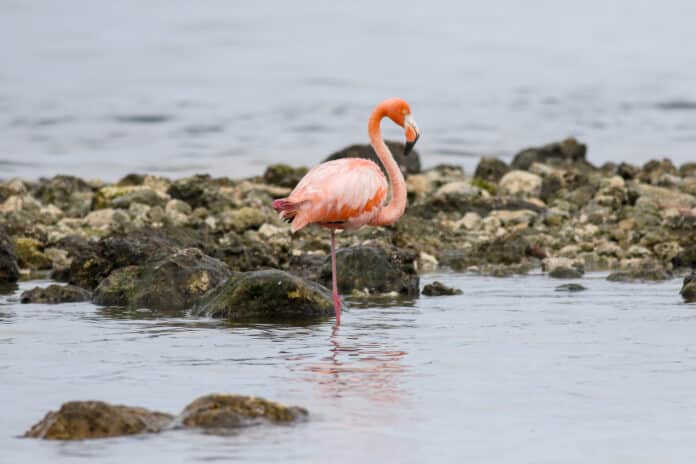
(320, 246, 420, 296)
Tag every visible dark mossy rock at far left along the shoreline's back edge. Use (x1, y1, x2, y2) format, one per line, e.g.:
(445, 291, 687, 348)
(35, 176, 94, 217)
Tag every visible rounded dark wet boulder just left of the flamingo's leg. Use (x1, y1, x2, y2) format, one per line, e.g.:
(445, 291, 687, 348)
(194, 269, 334, 321)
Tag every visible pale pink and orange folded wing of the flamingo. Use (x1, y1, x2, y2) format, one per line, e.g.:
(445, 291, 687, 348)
(287, 158, 388, 232)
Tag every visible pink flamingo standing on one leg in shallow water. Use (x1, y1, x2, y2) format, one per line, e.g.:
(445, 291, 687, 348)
(273, 98, 420, 326)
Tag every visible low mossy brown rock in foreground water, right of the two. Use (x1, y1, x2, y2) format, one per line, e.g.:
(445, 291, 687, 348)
(177, 394, 308, 429)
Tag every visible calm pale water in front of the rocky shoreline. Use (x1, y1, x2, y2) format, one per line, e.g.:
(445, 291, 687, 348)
(0, 274, 696, 463)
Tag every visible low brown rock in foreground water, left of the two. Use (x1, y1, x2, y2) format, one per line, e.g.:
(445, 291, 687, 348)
(24, 401, 174, 440)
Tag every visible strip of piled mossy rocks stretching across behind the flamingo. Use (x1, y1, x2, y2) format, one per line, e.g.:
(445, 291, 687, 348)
(0, 139, 696, 314)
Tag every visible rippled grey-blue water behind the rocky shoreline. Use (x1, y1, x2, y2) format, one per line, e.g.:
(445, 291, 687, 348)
(0, 0, 696, 180)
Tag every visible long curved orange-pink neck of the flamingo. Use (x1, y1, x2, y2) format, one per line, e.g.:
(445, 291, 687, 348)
(367, 105, 406, 226)
